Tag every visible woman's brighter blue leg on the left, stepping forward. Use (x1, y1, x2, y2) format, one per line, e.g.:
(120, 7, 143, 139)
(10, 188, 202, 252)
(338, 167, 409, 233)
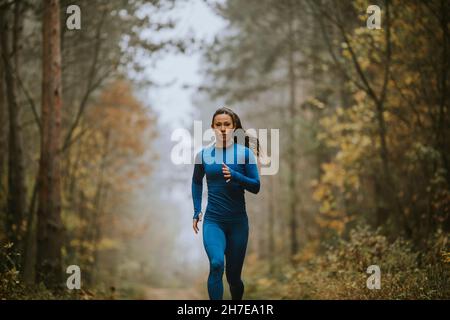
(203, 220, 226, 300)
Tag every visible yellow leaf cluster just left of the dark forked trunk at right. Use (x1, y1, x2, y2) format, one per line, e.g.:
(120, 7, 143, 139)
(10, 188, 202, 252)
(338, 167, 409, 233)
(312, 97, 376, 233)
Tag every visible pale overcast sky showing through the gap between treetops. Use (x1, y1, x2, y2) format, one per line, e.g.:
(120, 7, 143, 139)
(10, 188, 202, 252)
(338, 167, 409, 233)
(141, 0, 225, 128)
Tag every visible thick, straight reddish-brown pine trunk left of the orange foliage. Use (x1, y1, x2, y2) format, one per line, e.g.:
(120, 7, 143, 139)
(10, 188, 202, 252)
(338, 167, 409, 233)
(37, 0, 63, 288)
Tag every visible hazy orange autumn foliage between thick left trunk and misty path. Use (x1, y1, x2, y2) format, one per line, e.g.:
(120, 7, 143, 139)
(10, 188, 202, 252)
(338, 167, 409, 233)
(58, 81, 156, 262)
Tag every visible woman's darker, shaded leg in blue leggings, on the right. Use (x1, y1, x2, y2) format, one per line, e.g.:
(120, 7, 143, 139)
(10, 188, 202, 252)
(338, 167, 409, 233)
(225, 219, 249, 300)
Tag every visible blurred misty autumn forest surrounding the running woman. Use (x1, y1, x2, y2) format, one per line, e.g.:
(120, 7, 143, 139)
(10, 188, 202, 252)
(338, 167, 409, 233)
(0, 0, 450, 299)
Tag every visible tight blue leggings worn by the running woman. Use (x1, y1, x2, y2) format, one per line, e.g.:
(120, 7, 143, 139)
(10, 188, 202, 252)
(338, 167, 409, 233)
(203, 216, 249, 300)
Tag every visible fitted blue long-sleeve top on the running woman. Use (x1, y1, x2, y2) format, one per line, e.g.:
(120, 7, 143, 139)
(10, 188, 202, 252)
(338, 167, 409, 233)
(192, 143, 260, 222)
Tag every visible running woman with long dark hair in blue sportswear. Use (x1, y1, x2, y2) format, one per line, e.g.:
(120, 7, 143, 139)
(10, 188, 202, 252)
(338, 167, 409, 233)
(192, 107, 260, 300)
